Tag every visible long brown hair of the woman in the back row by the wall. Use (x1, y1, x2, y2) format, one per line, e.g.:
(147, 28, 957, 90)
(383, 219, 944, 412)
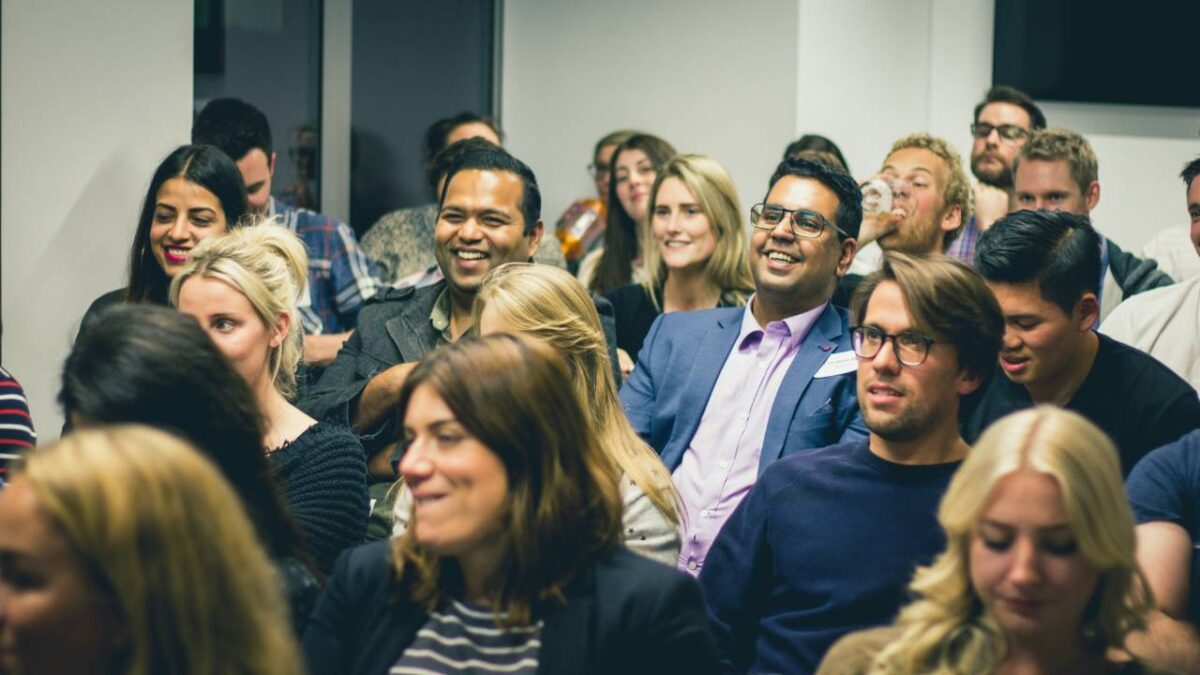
(588, 133, 676, 294)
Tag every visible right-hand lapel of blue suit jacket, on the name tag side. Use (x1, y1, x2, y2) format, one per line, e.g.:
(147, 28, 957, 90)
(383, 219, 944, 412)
(758, 304, 842, 476)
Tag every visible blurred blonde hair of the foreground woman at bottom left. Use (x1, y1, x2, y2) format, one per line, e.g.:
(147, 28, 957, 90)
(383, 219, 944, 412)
(16, 425, 304, 675)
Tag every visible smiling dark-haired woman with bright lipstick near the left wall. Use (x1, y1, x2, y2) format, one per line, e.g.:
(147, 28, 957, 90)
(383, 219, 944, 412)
(80, 145, 247, 331)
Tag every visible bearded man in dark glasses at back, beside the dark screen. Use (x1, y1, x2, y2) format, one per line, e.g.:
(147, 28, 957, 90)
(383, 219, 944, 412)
(946, 84, 1046, 264)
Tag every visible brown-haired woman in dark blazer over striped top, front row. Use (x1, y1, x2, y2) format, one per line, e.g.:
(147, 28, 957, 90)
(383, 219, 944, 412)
(304, 334, 716, 675)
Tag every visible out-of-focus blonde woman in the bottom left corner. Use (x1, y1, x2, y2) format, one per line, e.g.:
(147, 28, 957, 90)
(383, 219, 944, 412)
(0, 426, 304, 675)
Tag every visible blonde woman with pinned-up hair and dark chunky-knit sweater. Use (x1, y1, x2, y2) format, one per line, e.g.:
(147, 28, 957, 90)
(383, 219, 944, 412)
(170, 221, 368, 572)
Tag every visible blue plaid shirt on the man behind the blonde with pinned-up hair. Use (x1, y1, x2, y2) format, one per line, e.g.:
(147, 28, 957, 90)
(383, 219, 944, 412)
(270, 197, 382, 335)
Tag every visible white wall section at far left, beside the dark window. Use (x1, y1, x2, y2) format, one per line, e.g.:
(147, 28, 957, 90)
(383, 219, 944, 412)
(0, 0, 192, 441)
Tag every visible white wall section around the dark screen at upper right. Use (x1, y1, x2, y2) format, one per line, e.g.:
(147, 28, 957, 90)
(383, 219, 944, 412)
(796, 0, 1200, 251)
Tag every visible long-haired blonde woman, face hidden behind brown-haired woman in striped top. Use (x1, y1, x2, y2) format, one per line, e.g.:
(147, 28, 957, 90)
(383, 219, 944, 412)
(395, 263, 680, 566)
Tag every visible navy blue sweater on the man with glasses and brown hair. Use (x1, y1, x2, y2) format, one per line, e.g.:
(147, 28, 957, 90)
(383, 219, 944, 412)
(700, 441, 960, 673)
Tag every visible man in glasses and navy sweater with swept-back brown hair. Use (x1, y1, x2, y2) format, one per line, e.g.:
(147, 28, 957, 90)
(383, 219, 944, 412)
(700, 252, 1004, 673)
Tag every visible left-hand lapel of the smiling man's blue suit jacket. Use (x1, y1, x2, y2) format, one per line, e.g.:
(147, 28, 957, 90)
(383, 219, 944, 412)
(662, 310, 745, 471)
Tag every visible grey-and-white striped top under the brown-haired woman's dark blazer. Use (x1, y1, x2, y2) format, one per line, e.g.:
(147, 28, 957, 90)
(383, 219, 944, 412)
(390, 601, 542, 675)
